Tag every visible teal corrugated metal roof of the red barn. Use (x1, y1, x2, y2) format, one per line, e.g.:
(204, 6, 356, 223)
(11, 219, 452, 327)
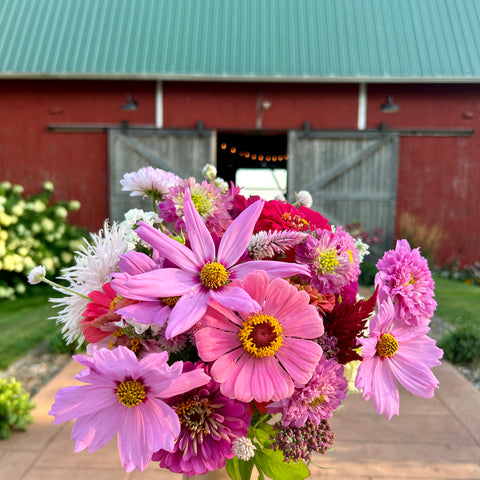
(0, 0, 480, 82)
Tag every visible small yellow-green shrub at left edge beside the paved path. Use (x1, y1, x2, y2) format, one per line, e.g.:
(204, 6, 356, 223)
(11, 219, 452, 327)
(0, 377, 35, 438)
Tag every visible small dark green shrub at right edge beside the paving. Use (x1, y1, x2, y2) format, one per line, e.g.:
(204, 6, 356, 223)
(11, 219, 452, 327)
(439, 325, 480, 363)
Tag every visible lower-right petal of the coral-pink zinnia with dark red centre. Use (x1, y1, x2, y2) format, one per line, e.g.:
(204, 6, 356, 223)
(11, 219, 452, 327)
(275, 337, 323, 385)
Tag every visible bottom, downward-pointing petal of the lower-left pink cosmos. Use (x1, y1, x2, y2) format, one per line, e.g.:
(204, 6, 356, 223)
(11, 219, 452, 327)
(117, 407, 151, 472)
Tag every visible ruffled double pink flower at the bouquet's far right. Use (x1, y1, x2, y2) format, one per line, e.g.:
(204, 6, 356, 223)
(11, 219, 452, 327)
(375, 240, 437, 325)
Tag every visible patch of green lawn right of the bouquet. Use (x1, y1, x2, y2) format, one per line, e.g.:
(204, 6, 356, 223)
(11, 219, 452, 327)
(434, 277, 480, 332)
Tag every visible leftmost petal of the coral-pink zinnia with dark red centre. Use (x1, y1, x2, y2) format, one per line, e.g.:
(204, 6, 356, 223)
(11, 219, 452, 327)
(195, 322, 240, 362)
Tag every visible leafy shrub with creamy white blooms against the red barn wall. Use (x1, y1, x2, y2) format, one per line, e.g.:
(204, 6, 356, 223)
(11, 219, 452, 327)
(0, 182, 86, 299)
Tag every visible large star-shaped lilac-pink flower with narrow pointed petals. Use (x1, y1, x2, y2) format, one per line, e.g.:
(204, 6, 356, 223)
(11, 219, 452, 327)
(112, 189, 307, 338)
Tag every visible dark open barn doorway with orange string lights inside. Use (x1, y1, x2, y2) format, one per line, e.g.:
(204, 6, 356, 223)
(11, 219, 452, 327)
(217, 132, 288, 200)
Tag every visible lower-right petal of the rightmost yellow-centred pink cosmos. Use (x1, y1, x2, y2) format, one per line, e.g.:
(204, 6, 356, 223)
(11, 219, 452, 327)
(389, 351, 438, 398)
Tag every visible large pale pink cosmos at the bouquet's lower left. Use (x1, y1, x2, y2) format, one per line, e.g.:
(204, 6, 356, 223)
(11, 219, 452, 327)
(49, 347, 210, 472)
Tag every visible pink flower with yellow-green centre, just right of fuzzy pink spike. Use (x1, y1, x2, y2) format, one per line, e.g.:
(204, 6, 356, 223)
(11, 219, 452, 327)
(296, 227, 360, 294)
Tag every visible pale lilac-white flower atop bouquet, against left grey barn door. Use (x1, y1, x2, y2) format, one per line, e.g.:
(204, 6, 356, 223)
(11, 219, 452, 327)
(120, 167, 181, 200)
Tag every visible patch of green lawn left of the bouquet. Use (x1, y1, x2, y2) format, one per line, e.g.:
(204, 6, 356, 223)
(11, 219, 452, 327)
(0, 294, 59, 370)
